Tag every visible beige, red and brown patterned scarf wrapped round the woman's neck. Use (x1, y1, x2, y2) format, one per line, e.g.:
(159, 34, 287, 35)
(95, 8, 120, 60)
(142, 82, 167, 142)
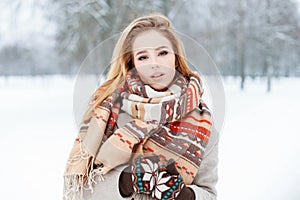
(64, 70, 211, 199)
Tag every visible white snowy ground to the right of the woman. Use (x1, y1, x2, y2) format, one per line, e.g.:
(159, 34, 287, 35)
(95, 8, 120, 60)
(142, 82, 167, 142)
(218, 79, 300, 200)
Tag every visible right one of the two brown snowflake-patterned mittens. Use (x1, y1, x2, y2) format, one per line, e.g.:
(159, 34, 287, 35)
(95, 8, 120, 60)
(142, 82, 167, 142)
(152, 159, 195, 200)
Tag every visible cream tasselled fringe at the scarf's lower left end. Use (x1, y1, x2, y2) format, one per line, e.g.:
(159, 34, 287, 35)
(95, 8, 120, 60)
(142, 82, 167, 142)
(63, 142, 104, 200)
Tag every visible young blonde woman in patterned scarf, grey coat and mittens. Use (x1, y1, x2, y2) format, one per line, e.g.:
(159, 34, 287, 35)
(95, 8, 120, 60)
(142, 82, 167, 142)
(64, 15, 218, 200)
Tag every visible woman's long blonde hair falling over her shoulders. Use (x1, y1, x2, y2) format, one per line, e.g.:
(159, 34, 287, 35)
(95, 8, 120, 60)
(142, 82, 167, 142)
(83, 14, 198, 120)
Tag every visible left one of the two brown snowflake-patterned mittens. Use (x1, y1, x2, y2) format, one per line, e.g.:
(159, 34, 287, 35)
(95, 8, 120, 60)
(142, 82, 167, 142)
(119, 156, 159, 197)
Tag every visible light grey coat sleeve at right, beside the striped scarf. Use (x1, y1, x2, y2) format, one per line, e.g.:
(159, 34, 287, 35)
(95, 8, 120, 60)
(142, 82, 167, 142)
(188, 128, 219, 200)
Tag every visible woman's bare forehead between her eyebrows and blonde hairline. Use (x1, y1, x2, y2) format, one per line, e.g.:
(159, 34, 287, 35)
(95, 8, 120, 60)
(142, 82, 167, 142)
(132, 30, 172, 51)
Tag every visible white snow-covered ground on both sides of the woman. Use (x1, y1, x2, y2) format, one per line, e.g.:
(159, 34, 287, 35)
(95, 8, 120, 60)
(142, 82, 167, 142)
(0, 76, 300, 200)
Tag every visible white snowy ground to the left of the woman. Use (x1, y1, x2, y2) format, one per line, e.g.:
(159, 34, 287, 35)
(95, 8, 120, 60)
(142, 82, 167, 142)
(0, 77, 76, 200)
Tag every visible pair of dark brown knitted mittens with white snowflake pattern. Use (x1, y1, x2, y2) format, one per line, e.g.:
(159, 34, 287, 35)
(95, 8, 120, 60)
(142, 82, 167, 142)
(119, 156, 195, 200)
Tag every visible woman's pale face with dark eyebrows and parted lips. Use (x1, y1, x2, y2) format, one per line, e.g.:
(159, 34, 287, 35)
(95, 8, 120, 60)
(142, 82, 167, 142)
(132, 30, 175, 90)
